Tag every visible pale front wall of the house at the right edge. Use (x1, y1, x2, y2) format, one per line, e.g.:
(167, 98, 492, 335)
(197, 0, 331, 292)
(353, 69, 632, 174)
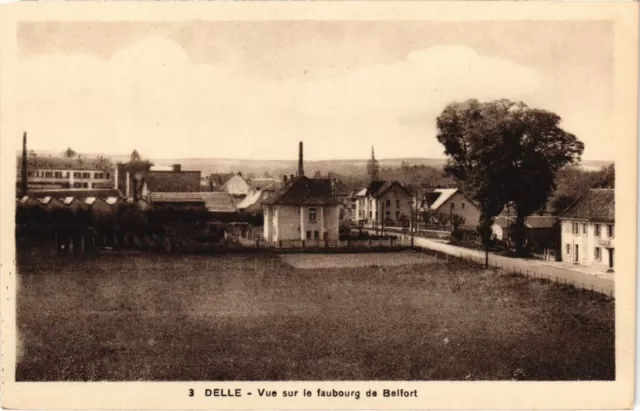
(561, 220, 615, 269)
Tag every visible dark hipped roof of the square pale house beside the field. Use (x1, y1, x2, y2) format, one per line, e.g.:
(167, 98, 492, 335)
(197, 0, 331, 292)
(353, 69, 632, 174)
(268, 176, 339, 205)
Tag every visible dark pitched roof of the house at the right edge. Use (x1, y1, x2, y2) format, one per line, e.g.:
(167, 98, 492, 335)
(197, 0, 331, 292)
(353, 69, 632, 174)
(560, 188, 616, 222)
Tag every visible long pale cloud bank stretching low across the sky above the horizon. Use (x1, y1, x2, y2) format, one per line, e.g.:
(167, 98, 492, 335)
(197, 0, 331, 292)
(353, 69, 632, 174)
(11, 38, 540, 158)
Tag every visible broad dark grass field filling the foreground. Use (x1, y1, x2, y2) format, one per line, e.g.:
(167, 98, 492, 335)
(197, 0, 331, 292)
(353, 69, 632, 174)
(16, 252, 615, 381)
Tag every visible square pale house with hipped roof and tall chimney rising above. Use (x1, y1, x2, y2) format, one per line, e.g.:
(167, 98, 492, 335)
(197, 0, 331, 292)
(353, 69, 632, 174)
(263, 142, 340, 245)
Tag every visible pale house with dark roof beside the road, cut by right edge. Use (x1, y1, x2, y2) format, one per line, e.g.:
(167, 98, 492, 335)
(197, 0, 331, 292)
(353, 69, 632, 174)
(559, 188, 615, 271)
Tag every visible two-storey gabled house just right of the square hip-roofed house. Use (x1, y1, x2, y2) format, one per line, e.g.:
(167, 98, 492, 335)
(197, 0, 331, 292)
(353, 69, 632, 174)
(355, 181, 413, 228)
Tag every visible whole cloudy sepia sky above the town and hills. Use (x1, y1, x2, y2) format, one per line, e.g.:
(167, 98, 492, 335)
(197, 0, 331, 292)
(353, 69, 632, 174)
(10, 21, 614, 160)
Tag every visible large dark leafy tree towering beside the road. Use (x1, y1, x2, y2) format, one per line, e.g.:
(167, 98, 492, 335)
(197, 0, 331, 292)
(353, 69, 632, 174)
(437, 100, 584, 255)
